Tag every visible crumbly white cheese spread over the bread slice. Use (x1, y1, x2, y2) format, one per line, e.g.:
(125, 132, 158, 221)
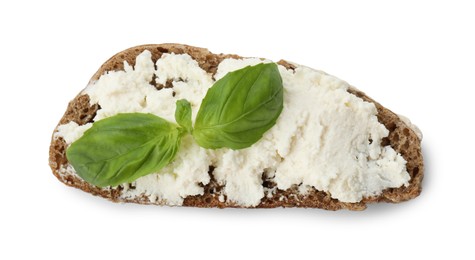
(56, 51, 410, 207)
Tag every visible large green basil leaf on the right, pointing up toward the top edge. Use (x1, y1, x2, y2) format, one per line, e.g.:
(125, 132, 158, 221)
(193, 63, 283, 149)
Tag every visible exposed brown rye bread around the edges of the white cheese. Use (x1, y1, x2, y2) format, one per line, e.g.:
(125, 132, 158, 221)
(49, 44, 424, 210)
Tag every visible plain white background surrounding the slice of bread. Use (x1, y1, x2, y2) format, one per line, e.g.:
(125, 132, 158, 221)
(0, 0, 475, 259)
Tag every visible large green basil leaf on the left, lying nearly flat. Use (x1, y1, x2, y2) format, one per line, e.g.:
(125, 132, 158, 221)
(66, 113, 182, 187)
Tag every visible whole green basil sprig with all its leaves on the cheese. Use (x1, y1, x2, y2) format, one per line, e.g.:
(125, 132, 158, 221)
(66, 63, 283, 187)
